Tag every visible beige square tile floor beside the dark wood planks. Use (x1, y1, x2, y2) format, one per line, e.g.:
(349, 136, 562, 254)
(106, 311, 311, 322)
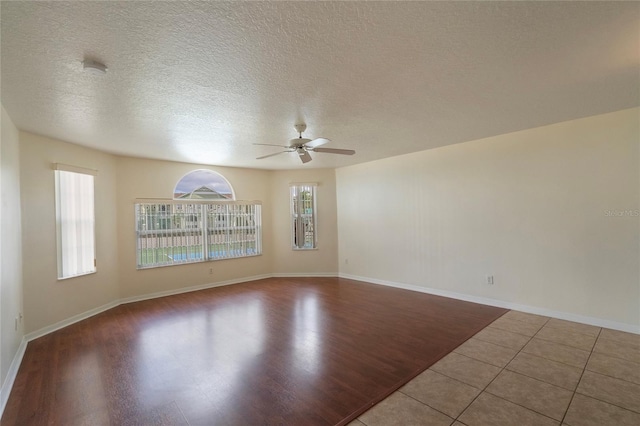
(348, 311, 640, 426)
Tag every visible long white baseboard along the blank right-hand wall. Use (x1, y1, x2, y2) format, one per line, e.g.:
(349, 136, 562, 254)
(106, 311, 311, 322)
(338, 273, 640, 334)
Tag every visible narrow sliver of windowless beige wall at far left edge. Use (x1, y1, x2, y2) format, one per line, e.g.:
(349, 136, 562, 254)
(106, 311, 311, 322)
(0, 107, 24, 392)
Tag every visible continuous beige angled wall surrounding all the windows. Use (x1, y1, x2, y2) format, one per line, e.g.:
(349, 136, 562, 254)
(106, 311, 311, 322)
(20, 132, 337, 333)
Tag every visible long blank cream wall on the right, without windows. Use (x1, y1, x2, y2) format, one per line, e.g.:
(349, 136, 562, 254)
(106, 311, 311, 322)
(336, 108, 640, 331)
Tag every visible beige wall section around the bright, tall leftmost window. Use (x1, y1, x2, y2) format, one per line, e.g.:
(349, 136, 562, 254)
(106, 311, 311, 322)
(20, 132, 119, 333)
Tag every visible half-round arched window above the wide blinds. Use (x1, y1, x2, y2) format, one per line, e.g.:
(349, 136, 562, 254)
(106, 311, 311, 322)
(173, 169, 236, 200)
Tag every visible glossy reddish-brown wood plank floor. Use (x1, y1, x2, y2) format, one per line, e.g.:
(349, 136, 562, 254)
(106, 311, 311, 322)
(2, 278, 507, 425)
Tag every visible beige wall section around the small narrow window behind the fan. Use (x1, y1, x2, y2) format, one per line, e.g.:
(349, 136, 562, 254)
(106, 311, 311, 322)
(271, 169, 338, 274)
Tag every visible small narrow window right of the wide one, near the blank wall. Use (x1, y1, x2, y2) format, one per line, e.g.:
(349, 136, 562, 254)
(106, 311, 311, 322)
(290, 183, 317, 250)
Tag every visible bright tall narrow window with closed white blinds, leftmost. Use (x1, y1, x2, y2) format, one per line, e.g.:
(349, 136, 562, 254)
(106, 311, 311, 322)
(54, 164, 96, 279)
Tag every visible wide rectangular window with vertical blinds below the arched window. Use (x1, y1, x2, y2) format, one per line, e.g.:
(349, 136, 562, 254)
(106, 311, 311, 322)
(135, 200, 262, 269)
